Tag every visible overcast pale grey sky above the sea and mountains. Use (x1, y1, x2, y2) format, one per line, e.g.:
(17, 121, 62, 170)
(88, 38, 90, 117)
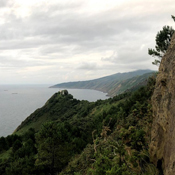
(0, 0, 175, 84)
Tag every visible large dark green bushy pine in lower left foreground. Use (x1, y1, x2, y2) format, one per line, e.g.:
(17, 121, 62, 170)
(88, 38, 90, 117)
(36, 122, 70, 175)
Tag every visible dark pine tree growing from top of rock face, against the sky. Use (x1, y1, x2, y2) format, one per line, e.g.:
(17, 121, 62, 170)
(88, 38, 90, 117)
(148, 16, 175, 65)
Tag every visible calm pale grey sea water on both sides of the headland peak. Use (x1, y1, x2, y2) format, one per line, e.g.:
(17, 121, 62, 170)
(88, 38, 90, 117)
(0, 85, 108, 137)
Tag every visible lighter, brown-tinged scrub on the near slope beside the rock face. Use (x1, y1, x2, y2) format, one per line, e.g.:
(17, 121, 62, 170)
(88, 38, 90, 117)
(61, 77, 157, 175)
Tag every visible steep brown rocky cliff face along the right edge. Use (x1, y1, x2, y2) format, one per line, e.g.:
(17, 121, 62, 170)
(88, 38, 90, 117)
(150, 34, 175, 175)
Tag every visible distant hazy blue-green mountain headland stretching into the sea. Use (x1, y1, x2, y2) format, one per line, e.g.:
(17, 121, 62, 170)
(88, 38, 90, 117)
(50, 69, 155, 97)
